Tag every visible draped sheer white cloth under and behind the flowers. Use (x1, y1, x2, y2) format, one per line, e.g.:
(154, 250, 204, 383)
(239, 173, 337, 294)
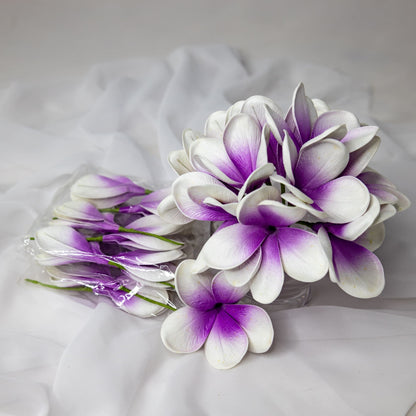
(0, 45, 416, 416)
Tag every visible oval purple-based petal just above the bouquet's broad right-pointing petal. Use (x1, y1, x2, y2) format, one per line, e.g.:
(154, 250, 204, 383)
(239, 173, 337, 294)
(295, 139, 348, 189)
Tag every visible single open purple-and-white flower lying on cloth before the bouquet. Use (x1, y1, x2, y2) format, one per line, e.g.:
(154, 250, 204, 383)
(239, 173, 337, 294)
(161, 260, 274, 369)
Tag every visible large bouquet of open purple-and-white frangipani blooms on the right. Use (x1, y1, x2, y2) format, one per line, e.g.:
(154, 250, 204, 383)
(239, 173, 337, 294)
(159, 84, 409, 303)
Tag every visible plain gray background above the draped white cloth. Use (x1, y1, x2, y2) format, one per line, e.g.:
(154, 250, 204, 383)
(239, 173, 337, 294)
(0, 0, 416, 122)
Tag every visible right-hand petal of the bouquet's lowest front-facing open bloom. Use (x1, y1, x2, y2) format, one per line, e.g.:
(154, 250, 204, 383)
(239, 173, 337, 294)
(277, 228, 328, 282)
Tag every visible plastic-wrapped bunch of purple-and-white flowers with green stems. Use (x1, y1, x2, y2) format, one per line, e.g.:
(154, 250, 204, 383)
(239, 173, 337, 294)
(32, 174, 184, 317)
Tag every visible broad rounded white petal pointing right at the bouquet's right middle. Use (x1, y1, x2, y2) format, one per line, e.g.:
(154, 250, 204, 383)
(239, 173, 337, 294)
(308, 176, 370, 223)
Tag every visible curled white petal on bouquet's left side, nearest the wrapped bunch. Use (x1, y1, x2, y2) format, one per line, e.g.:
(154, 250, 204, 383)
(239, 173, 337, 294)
(172, 172, 237, 221)
